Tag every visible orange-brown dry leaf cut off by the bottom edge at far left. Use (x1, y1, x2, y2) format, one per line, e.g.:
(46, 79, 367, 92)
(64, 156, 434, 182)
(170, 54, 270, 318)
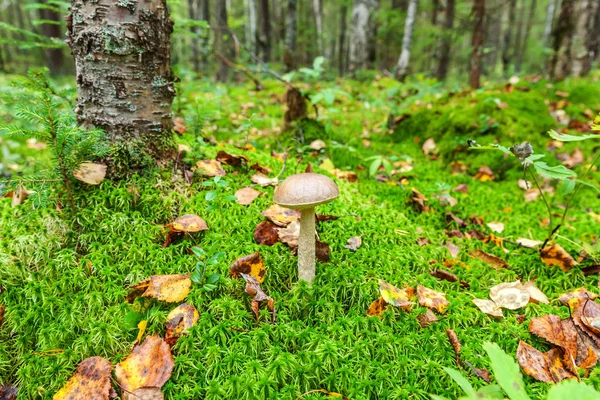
(52, 357, 112, 400)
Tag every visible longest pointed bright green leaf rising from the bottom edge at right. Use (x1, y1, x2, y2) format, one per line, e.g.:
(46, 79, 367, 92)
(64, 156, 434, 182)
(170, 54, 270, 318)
(483, 342, 531, 400)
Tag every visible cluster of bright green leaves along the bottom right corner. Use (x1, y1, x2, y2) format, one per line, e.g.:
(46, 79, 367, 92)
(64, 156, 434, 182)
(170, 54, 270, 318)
(431, 342, 600, 400)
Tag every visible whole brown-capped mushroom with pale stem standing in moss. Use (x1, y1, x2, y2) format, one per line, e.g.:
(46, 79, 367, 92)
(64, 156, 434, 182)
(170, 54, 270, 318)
(273, 172, 339, 284)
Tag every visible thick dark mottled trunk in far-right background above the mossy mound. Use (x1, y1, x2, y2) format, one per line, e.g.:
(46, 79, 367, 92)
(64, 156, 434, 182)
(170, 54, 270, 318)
(548, 0, 575, 80)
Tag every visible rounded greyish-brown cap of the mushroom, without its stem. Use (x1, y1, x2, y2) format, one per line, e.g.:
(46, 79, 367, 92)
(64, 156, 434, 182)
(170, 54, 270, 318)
(273, 172, 340, 210)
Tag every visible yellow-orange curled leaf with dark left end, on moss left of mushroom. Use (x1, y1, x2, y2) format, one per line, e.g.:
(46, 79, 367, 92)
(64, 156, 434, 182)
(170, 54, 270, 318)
(127, 274, 192, 303)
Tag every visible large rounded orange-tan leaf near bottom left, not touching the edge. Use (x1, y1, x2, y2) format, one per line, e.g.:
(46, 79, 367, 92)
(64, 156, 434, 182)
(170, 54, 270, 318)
(115, 336, 175, 392)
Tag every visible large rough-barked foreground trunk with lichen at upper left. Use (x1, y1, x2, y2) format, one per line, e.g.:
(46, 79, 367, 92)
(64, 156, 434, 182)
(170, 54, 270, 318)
(67, 0, 175, 168)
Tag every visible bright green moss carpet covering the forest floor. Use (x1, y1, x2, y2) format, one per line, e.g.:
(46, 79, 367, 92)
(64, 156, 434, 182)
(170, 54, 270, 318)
(0, 73, 600, 399)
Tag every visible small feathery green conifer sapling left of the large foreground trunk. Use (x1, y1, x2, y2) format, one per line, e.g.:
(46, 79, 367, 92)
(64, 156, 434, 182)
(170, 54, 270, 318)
(0, 69, 109, 214)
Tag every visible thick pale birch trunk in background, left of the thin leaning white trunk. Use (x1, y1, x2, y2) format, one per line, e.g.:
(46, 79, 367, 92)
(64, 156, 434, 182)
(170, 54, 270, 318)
(348, 0, 377, 72)
